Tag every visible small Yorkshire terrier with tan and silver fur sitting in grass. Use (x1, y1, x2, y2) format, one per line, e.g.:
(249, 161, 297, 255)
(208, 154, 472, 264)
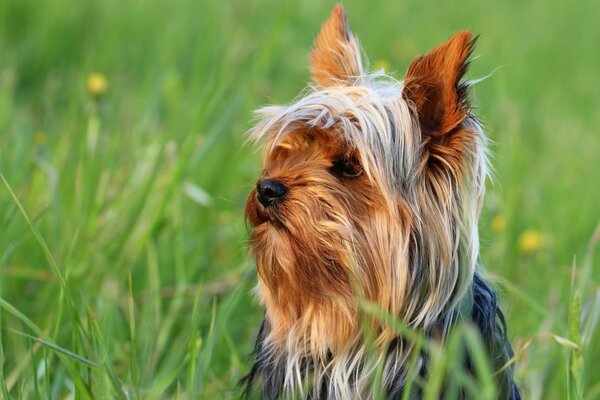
(243, 5, 520, 399)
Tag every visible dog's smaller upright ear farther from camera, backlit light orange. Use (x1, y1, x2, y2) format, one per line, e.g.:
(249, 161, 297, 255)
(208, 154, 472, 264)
(310, 4, 363, 87)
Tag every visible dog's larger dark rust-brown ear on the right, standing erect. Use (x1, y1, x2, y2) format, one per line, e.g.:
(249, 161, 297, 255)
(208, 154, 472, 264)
(403, 31, 475, 137)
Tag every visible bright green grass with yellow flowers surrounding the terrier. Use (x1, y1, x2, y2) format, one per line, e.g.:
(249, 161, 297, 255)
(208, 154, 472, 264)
(0, 0, 600, 399)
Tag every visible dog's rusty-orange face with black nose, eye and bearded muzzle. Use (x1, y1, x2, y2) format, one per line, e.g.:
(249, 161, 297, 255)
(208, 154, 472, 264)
(247, 127, 385, 300)
